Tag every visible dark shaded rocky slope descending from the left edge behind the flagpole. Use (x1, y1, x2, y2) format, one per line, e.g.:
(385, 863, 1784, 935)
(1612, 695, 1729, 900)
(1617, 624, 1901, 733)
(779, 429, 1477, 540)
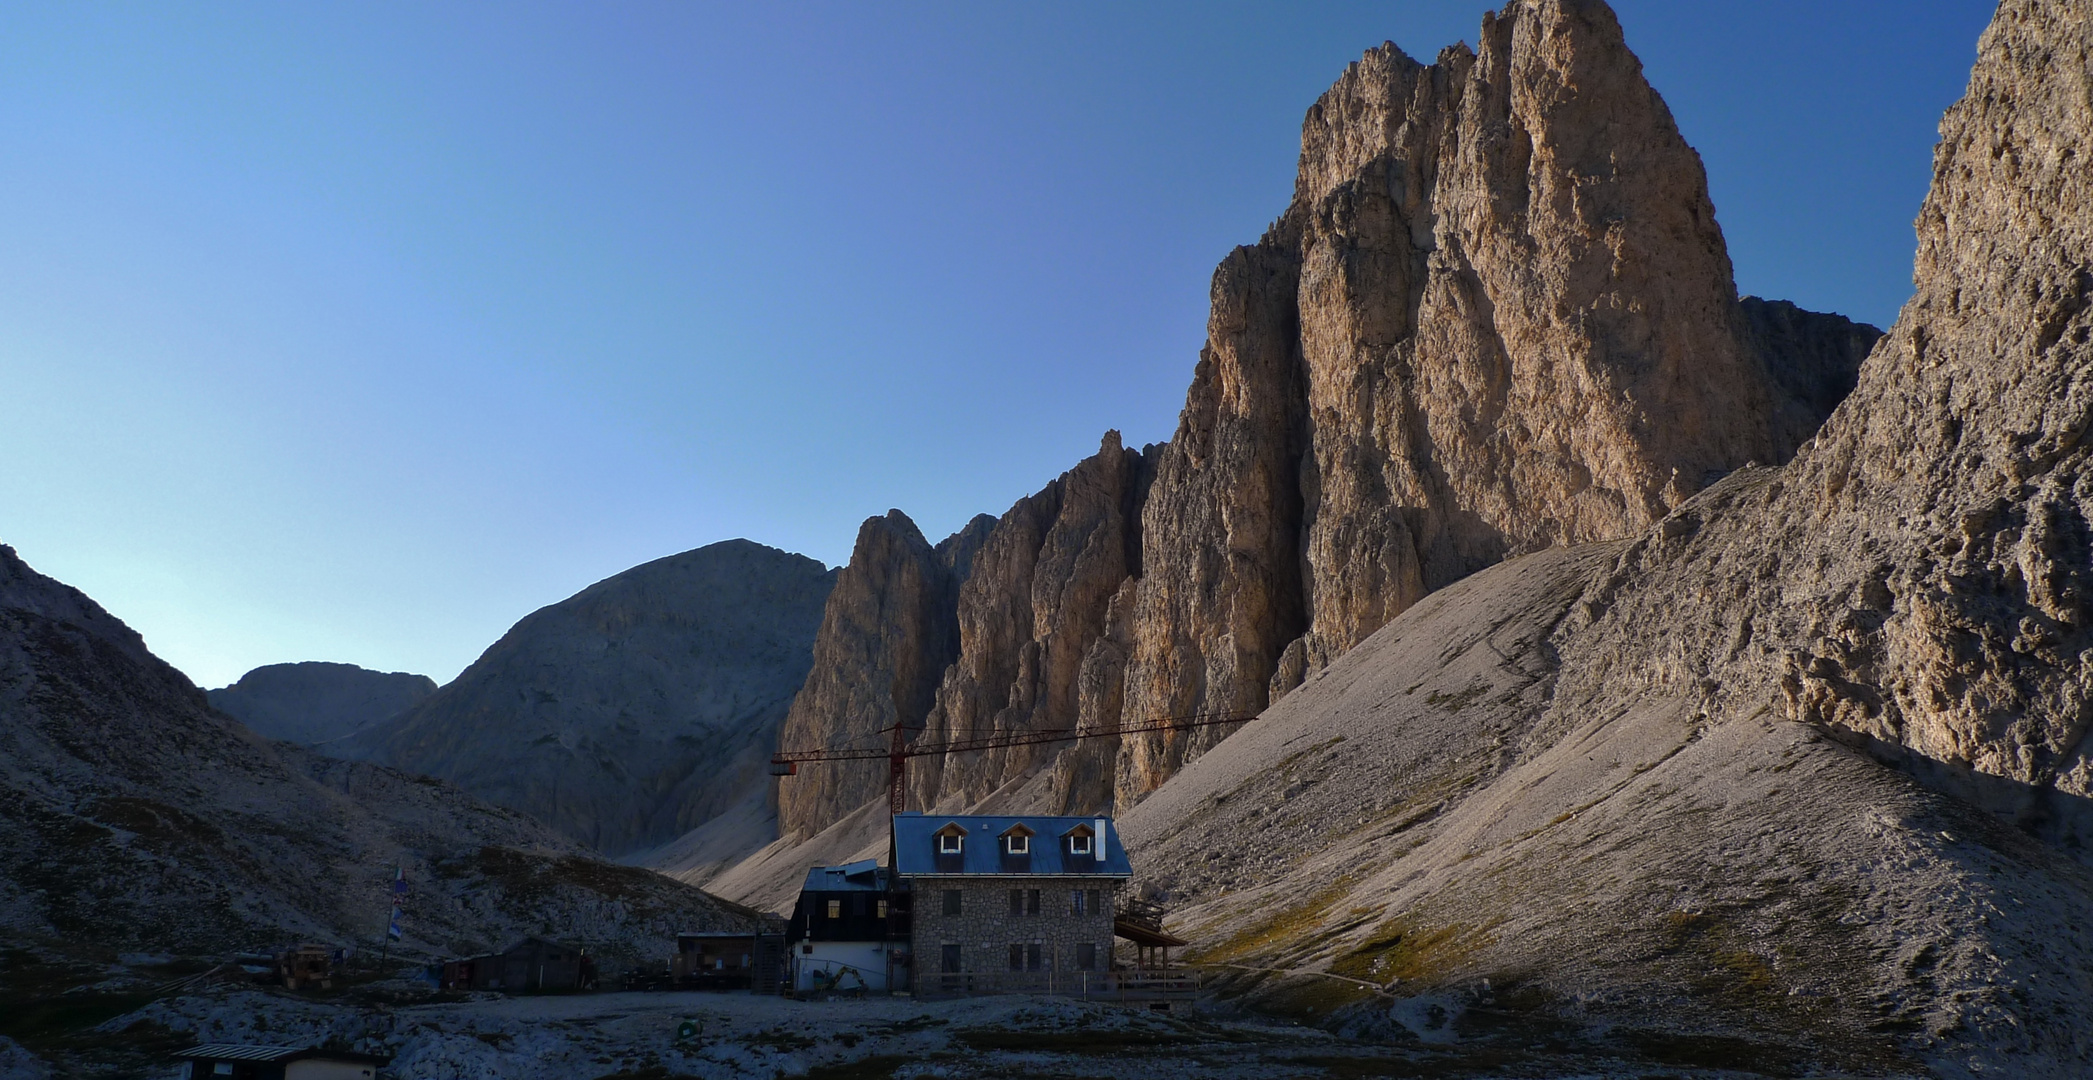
(0, 546, 756, 966)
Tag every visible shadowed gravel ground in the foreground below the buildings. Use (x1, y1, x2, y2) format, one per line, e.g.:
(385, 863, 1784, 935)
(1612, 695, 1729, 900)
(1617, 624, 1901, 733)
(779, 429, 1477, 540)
(24, 984, 1875, 1080)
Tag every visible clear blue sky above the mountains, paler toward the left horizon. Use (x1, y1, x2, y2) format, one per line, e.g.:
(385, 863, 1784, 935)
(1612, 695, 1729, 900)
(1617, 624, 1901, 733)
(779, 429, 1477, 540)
(0, 0, 1990, 687)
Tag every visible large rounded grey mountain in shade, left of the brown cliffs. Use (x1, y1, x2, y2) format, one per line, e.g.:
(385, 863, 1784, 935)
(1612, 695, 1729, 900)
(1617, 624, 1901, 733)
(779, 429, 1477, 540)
(347, 540, 835, 854)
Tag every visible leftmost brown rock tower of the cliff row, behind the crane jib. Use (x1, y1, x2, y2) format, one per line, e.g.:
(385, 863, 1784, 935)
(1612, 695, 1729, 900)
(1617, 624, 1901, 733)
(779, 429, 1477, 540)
(777, 511, 992, 835)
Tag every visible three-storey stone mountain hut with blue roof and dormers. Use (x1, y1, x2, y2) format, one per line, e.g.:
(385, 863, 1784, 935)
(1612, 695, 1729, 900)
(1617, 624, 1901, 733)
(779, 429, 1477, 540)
(894, 814, 1134, 994)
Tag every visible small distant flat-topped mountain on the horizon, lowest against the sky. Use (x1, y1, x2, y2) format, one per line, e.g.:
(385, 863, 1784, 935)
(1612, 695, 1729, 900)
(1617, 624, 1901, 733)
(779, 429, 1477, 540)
(207, 659, 435, 745)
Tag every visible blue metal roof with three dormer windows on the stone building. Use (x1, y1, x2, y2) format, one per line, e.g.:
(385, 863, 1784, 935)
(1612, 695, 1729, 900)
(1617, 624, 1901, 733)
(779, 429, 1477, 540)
(894, 814, 1134, 877)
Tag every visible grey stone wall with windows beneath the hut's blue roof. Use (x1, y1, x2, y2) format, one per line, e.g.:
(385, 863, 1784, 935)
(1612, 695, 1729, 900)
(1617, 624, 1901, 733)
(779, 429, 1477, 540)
(910, 875, 1122, 994)
